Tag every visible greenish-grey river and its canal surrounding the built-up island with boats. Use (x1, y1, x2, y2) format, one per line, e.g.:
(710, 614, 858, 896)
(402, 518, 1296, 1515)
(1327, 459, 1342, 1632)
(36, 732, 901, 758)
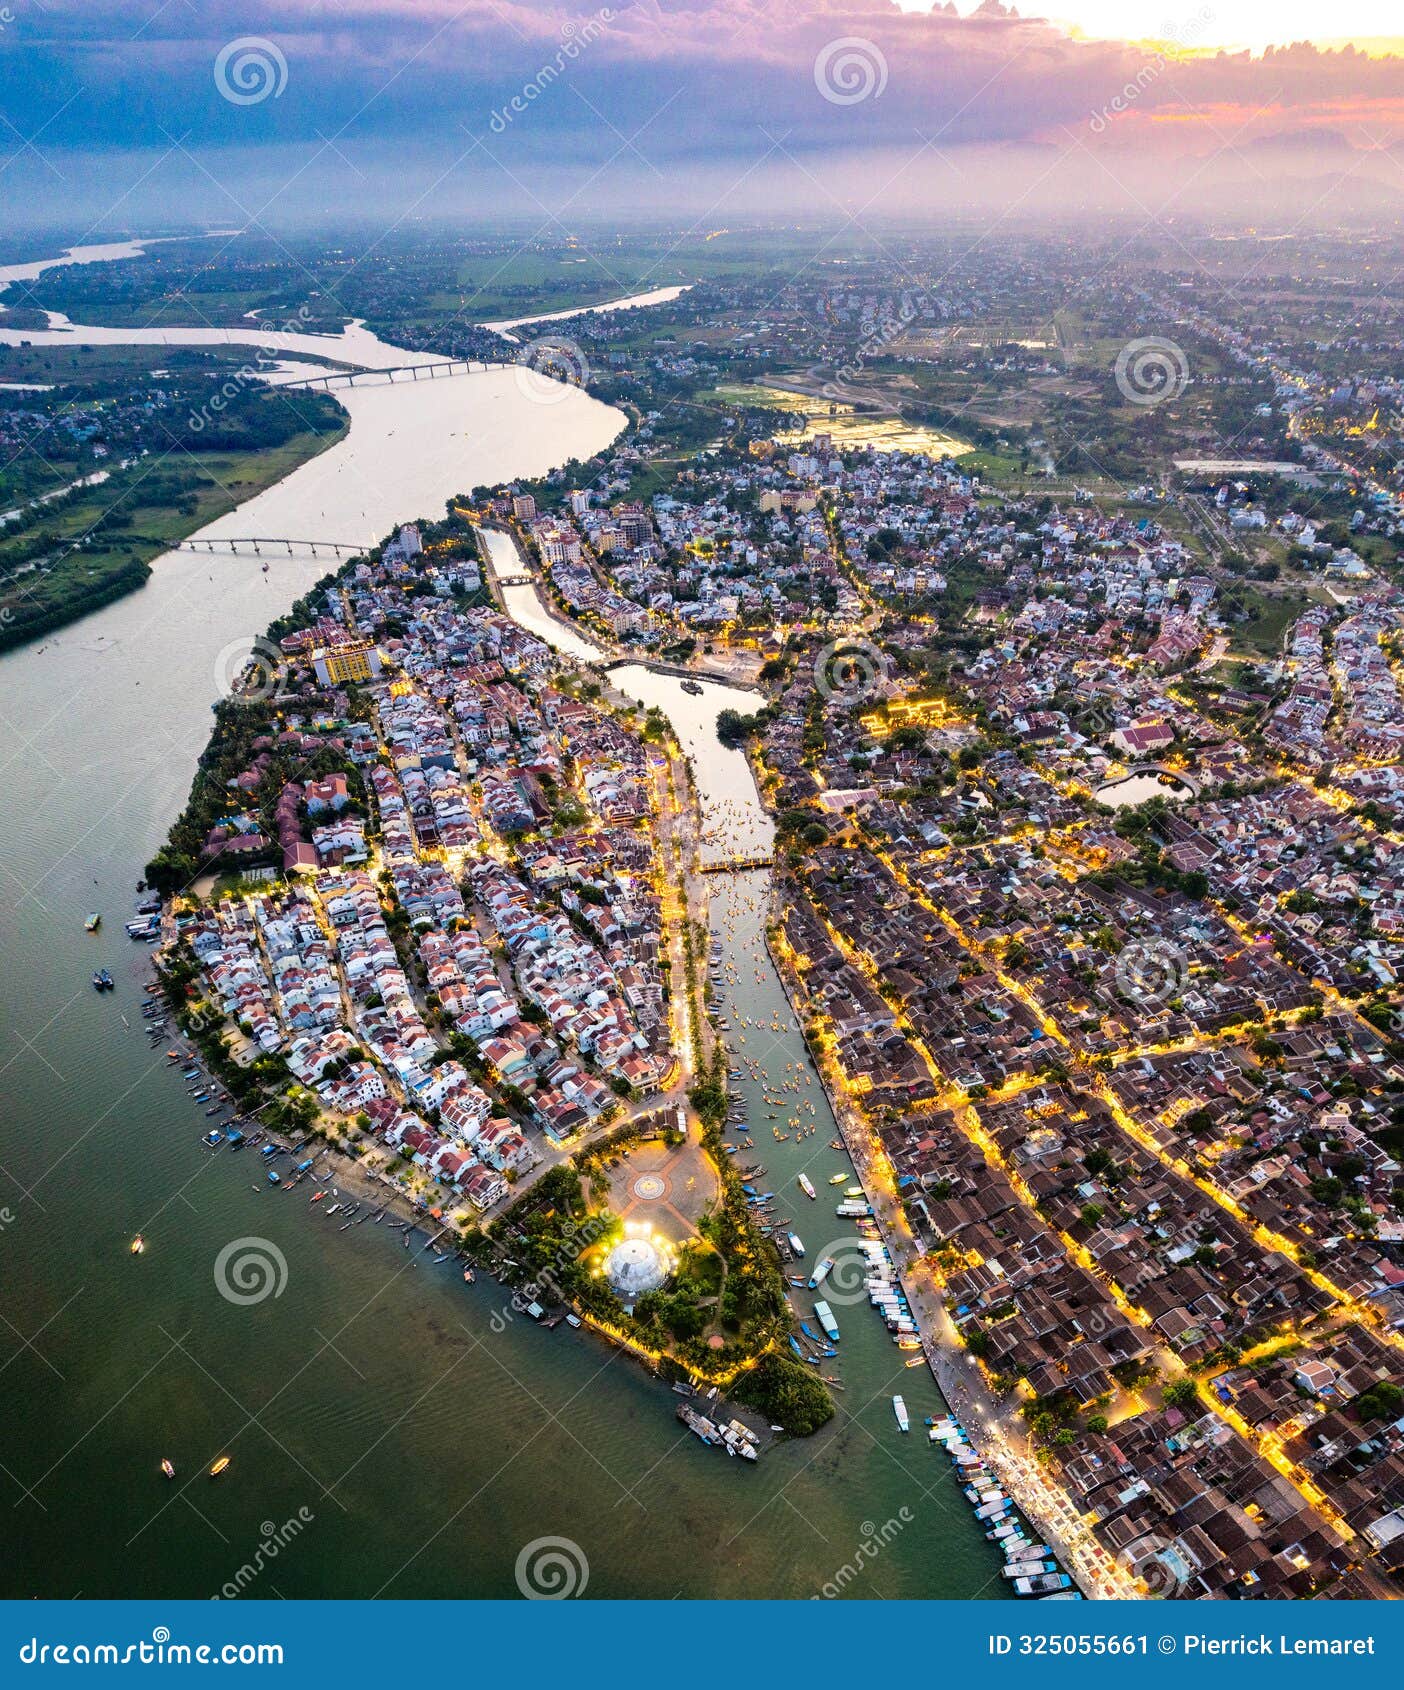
(0, 248, 1007, 1597)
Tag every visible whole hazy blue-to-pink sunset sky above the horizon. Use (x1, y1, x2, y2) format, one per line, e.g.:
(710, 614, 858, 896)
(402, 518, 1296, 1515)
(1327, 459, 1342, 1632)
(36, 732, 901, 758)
(0, 0, 1404, 230)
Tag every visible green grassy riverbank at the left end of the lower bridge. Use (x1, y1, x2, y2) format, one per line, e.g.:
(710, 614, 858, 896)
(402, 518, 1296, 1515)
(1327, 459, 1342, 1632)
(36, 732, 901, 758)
(0, 429, 345, 651)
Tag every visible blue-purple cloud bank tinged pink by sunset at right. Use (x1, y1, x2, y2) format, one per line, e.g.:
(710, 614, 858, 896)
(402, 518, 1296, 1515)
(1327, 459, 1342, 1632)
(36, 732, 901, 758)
(0, 0, 1404, 221)
